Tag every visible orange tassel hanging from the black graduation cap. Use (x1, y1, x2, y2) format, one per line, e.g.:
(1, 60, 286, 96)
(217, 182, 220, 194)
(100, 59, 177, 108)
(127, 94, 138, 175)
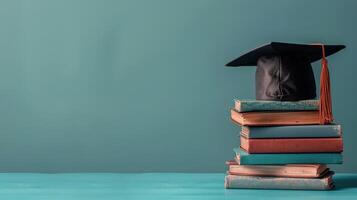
(319, 44, 333, 124)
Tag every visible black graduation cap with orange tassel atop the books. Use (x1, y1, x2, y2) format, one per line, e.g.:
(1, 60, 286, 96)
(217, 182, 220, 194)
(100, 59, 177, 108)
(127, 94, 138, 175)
(226, 42, 345, 124)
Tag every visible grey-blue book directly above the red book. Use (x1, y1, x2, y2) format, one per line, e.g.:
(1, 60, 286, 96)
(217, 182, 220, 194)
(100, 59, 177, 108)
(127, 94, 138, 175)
(240, 124, 342, 138)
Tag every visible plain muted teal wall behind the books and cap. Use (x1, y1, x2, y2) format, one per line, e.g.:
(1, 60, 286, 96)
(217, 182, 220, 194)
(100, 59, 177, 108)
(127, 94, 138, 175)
(0, 0, 357, 173)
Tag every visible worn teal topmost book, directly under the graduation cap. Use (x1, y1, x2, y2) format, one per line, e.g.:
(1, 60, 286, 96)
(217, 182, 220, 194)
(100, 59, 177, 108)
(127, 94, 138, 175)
(234, 99, 319, 112)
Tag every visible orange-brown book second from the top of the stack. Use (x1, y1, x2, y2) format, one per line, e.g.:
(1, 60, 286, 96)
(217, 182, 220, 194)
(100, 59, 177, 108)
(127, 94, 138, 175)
(231, 109, 320, 126)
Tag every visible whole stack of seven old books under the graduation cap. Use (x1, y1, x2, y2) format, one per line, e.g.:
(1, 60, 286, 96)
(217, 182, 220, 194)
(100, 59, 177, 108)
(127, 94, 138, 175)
(225, 100, 343, 190)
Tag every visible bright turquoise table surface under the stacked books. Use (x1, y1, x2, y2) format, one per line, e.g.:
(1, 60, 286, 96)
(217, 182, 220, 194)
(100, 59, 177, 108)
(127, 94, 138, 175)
(0, 173, 357, 200)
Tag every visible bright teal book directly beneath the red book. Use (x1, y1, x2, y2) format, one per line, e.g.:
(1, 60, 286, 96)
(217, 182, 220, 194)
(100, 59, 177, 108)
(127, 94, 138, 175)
(234, 148, 343, 165)
